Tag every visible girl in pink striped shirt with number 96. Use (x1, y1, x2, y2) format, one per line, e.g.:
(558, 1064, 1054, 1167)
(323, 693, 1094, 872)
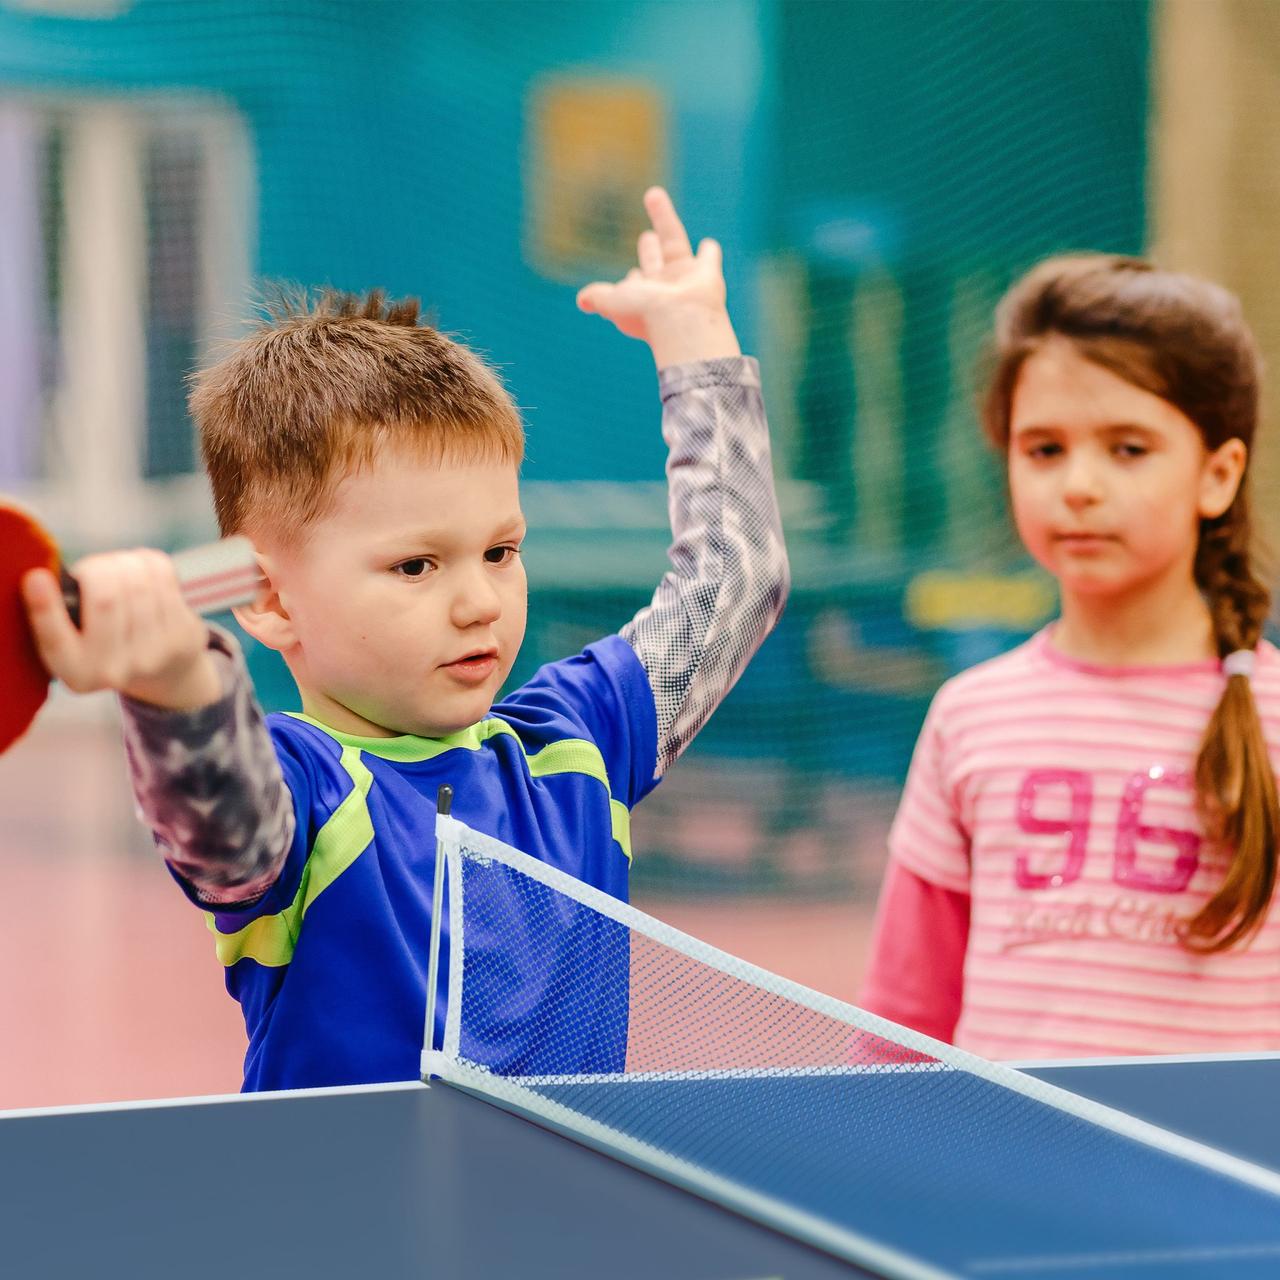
(863, 255, 1280, 1059)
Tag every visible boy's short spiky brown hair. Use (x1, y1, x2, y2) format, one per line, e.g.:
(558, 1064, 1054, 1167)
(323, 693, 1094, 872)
(191, 289, 525, 534)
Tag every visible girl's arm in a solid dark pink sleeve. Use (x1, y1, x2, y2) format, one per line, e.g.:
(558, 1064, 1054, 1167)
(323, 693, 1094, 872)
(859, 861, 969, 1041)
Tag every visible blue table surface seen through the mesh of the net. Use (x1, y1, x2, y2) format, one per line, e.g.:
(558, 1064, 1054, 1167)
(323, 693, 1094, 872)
(522, 1069, 1280, 1280)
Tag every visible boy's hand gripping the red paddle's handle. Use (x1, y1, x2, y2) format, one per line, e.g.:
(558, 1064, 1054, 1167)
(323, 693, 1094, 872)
(22, 550, 221, 710)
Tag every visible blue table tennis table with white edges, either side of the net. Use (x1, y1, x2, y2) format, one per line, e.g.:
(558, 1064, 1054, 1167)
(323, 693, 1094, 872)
(0, 1055, 1280, 1280)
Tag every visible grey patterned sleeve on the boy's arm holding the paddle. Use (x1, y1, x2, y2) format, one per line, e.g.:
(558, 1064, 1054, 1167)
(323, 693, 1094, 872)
(120, 626, 294, 906)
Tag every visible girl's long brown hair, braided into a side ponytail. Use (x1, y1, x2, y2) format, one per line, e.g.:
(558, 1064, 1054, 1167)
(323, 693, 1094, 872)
(983, 253, 1280, 951)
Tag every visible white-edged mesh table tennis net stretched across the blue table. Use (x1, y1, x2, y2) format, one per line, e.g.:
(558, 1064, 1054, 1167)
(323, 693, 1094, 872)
(424, 818, 1280, 1276)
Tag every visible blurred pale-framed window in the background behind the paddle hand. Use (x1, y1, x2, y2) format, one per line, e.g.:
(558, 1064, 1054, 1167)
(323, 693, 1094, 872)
(0, 97, 253, 544)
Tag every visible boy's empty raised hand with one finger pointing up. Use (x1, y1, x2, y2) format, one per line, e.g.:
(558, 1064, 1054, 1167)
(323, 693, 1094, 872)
(577, 187, 741, 369)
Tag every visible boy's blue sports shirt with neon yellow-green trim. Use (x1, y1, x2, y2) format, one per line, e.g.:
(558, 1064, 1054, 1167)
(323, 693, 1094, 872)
(210, 636, 658, 1089)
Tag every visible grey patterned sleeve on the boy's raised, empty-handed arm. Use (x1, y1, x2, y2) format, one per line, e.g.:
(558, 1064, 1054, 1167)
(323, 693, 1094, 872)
(622, 356, 790, 776)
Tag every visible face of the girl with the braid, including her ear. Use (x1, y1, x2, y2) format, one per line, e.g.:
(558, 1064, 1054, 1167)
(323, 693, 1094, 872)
(1009, 338, 1245, 596)
